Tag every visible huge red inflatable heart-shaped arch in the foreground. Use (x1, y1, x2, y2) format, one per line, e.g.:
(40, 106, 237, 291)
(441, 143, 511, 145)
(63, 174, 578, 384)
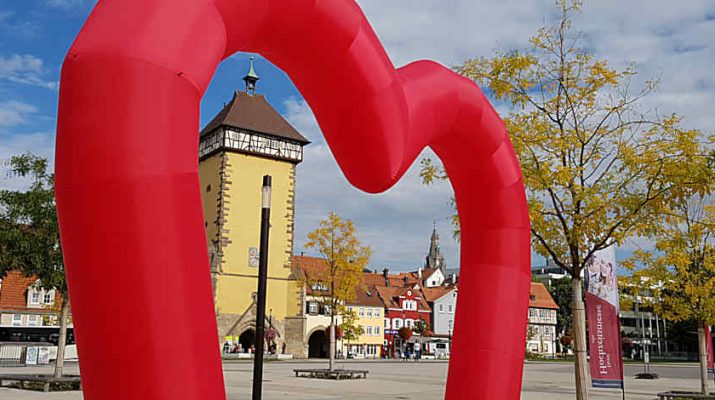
(56, 0, 530, 400)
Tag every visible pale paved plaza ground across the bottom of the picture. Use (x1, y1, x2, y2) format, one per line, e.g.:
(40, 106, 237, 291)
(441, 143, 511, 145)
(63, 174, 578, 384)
(0, 361, 699, 400)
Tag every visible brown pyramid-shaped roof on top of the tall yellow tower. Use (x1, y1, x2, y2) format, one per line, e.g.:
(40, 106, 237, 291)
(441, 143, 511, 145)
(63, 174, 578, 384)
(201, 89, 310, 144)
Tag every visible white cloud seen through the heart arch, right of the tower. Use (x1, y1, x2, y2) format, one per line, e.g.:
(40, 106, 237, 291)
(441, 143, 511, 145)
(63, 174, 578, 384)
(284, 99, 458, 269)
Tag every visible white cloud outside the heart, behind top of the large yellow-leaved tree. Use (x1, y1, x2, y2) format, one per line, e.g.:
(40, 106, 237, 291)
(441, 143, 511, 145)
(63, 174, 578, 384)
(358, 0, 715, 262)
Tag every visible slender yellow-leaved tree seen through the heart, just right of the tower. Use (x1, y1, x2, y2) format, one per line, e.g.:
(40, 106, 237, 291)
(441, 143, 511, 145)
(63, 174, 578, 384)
(305, 212, 372, 371)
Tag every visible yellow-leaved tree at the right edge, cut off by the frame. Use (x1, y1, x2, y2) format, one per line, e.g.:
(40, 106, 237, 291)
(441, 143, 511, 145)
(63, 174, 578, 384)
(626, 197, 715, 394)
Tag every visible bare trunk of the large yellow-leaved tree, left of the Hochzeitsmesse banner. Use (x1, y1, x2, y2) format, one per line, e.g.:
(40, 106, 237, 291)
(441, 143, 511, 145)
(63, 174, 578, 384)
(571, 277, 588, 400)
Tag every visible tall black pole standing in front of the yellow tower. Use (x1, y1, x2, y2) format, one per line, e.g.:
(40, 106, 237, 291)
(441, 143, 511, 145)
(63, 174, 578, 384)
(253, 175, 271, 400)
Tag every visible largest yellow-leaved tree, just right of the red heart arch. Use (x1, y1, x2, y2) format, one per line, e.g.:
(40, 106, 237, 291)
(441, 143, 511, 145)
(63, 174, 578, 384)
(421, 0, 707, 400)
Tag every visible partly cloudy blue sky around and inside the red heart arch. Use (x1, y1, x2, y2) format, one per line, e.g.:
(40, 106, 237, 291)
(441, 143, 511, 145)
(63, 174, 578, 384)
(0, 0, 715, 269)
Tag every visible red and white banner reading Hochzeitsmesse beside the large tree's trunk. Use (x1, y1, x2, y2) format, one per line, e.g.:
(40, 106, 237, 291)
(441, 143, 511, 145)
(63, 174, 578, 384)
(585, 247, 623, 389)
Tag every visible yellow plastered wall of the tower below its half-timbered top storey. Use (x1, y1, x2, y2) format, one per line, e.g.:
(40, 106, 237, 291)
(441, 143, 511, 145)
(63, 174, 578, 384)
(199, 151, 301, 342)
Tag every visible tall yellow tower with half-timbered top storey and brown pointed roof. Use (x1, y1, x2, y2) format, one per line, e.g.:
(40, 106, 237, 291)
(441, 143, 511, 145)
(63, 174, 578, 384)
(199, 61, 309, 354)
